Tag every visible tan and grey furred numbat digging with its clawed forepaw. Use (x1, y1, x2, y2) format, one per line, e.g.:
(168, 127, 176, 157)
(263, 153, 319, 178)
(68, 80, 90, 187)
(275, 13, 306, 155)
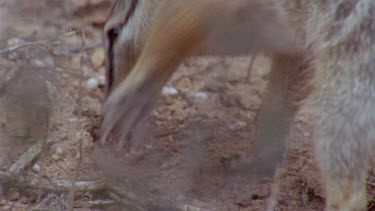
(101, 0, 375, 210)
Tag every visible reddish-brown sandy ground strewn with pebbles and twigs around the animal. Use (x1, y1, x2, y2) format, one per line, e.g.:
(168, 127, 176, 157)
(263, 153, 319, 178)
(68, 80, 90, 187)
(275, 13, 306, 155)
(0, 0, 375, 210)
